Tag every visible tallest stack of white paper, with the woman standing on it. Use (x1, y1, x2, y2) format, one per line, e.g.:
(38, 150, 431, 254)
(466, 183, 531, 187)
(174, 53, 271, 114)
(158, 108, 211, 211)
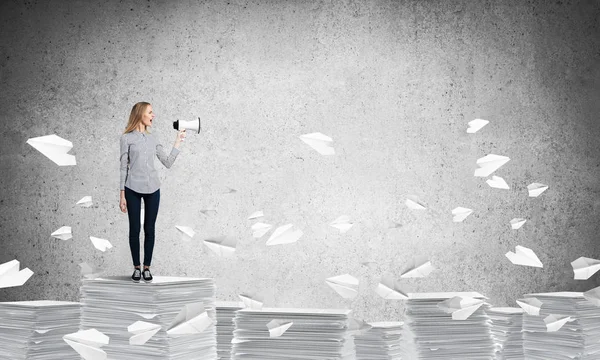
(81, 276, 217, 360)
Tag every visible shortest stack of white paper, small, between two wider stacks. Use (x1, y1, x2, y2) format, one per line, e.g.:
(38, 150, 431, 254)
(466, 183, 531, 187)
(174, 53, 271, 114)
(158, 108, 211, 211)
(354, 321, 404, 360)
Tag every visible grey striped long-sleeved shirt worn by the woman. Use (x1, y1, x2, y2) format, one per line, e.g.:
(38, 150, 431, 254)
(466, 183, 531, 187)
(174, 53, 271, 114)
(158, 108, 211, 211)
(120, 130, 179, 194)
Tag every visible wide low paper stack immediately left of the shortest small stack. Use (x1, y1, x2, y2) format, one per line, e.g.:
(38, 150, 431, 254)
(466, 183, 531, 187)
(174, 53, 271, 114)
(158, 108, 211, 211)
(231, 308, 355, 360)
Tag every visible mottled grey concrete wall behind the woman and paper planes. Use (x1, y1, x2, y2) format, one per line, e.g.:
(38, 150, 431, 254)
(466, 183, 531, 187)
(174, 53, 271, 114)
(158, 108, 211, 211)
(0, 0, 600, 320)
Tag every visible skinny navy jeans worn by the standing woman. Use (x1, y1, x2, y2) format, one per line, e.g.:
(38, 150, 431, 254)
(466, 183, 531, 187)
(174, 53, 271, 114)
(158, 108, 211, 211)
(125, 187, 160, 266)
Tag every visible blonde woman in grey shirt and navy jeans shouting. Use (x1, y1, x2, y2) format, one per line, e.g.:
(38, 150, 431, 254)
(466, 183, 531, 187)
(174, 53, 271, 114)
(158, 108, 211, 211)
(119, 102, 185, 282)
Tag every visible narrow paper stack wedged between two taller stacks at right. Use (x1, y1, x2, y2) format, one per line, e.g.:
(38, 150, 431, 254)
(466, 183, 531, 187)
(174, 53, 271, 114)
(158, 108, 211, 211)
(488, 307, 524, 360)
